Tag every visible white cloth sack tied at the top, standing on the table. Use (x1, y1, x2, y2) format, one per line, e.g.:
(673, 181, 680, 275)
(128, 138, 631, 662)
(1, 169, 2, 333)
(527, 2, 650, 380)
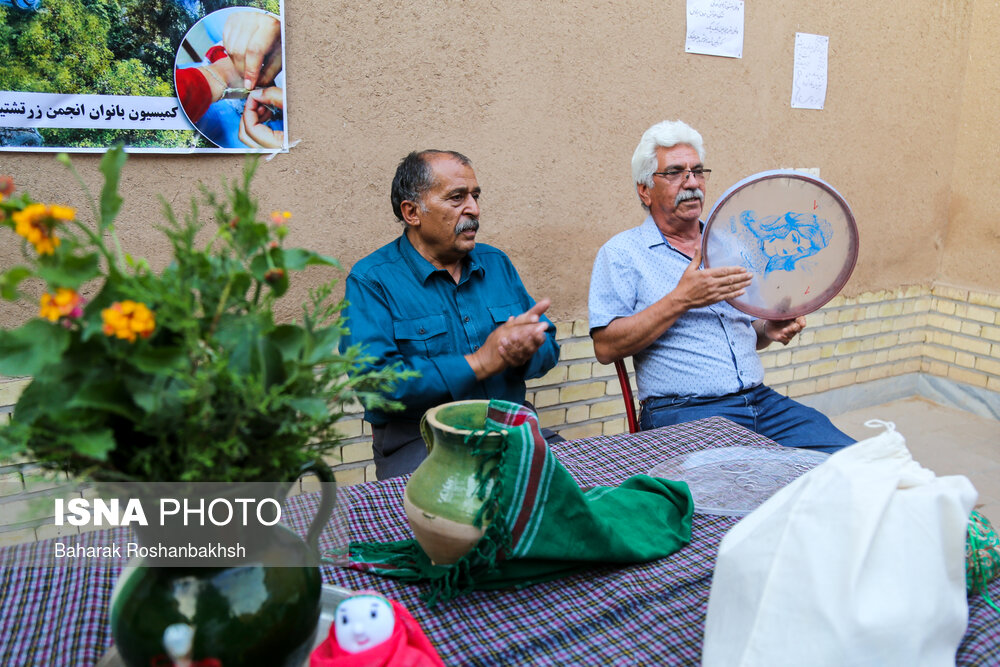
(702, 421, 977, 667)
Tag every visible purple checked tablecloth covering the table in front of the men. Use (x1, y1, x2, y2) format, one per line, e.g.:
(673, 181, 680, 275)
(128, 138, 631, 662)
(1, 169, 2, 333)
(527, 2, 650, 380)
(0, 417, 1000, 667)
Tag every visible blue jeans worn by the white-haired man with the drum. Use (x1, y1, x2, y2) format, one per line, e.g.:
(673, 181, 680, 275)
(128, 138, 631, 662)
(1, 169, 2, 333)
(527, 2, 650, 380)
(639, 384, 855, 452)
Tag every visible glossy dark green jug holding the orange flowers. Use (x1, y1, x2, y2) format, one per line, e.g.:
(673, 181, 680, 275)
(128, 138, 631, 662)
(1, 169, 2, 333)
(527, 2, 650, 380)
(111, 461, 335, 667)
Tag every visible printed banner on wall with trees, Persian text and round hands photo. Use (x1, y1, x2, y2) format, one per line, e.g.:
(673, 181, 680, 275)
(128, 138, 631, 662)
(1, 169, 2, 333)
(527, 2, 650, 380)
(0, 0, 288, 153)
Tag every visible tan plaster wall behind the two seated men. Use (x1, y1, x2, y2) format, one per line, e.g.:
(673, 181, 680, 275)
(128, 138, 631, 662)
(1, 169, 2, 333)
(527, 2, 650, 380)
(0, 0, 984, 326)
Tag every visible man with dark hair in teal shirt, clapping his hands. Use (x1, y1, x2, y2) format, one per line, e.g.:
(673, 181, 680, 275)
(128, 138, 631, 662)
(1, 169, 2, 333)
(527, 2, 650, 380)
(342, 150, 559, 479)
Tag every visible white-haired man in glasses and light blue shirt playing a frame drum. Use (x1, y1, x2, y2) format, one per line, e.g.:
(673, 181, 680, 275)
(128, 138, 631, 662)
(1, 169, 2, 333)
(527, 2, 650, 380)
(589, 121, 854, 452)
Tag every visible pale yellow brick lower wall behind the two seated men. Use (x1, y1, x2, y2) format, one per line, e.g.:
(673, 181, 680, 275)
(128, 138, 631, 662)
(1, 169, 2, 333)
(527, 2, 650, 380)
(0, 285, 1000, 544)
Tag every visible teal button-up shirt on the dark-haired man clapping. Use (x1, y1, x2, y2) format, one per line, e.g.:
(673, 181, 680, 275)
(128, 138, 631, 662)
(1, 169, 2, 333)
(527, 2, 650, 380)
(341, 234, 559, 424)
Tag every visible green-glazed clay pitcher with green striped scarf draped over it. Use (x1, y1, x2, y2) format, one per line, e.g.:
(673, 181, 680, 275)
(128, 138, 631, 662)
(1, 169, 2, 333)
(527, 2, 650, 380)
(403, 401, 506, 564)
